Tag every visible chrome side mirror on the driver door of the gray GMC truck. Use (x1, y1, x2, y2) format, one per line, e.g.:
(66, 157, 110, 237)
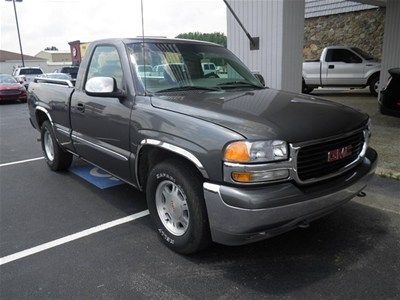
(85, 77, 125, 98)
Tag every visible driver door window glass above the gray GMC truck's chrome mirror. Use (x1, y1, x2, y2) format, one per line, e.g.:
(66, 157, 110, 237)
(87, 46, 123, 88)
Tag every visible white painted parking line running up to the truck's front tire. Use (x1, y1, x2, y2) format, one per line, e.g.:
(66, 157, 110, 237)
(0, 209, 149, 266)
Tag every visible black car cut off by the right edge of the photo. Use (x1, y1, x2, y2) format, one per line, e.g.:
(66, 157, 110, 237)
(378, 68, 400, 117)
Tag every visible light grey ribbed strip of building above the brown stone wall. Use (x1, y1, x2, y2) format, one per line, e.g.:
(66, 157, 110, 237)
(305, 0, 375, 19)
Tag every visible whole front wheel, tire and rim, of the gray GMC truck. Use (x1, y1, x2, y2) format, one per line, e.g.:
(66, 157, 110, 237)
(146, 160, 211, 254)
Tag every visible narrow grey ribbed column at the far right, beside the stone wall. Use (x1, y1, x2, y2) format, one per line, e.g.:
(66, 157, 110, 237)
(380, 0, 400, 89)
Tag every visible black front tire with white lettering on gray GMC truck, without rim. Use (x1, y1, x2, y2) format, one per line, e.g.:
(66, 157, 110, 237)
(146, 159, 211, 254)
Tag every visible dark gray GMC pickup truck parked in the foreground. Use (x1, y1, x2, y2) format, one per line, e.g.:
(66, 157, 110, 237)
(28, 38, 377, 254)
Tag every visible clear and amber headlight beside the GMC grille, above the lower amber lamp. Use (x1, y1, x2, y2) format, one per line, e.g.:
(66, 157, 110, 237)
(224, 140, 288, 163)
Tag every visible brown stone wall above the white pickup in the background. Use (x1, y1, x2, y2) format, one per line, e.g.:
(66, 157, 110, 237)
(303, 8, 385, 59)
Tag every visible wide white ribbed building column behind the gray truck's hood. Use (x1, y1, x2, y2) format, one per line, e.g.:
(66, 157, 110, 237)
(227, 0, 304, 92)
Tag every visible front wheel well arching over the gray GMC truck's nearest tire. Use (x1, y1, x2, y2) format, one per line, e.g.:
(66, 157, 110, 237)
(136, 145, 203, 190)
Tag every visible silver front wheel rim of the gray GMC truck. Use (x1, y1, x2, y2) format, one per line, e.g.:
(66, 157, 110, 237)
(156, 180, 190, 236)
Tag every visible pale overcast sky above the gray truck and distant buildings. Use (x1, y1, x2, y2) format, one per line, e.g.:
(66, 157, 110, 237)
(0, 0, 226, 55)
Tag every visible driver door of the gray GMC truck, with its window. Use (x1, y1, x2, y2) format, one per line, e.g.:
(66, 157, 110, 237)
(71, 45, 131, 180)
